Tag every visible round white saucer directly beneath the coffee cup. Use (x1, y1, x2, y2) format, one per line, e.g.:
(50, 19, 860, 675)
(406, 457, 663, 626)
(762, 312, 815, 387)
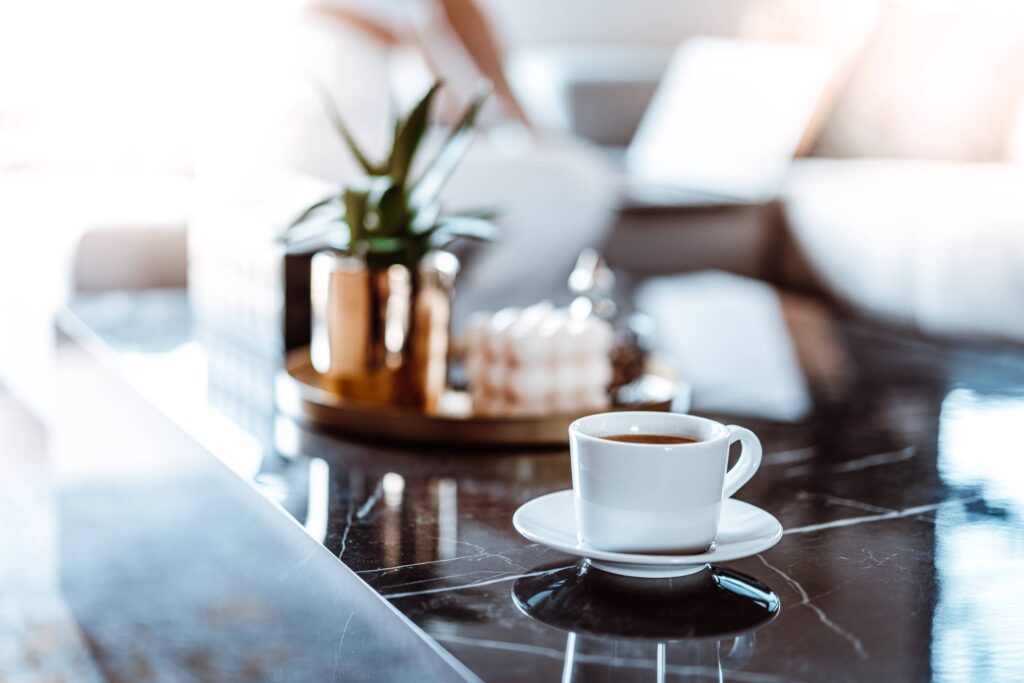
(512, 489, 782, 579)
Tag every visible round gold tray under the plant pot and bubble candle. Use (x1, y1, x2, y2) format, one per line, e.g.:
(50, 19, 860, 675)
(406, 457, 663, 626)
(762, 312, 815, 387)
(276, 348, 679, 445)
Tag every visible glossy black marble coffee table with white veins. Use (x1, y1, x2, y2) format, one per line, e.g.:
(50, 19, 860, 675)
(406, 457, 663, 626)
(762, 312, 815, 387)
(51, 292, 1024, 683)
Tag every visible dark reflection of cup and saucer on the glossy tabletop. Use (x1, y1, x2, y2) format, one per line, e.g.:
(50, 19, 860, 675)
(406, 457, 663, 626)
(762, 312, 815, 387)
(512, 562, 779, 681)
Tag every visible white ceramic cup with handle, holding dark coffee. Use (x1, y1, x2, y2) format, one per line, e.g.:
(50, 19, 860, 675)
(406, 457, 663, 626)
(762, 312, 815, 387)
(569, 412, 761, 553)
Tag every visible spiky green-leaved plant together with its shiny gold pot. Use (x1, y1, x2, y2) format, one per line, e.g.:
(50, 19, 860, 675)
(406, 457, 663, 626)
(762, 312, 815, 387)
(287, 83, 496, 411)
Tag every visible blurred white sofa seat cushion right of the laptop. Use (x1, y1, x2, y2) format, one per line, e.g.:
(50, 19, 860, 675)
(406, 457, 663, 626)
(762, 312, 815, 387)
(783, 160, 1024, 341)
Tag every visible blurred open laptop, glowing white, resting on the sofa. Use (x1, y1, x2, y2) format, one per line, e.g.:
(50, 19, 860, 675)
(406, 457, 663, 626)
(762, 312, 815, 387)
(623, 38, 830, 206)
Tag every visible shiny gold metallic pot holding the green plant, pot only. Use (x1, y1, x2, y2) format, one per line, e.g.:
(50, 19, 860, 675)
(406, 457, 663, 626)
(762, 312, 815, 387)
(310, 251, 459, 413)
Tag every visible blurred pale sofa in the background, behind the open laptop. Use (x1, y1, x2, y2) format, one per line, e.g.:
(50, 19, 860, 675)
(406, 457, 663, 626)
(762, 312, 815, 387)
(488, 0, 1024, 342)
